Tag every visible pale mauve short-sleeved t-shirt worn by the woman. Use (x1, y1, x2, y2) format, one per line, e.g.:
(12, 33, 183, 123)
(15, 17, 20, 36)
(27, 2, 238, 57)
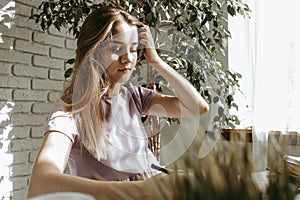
(45, 84, 158, 181)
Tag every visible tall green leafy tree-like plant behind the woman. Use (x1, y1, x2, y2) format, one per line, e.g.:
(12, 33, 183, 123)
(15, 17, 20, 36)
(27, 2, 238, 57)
(30, 0, 250, 128)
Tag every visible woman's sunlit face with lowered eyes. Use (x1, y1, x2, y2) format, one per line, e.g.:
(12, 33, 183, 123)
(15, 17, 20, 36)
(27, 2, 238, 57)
(101, 22, 138, 84)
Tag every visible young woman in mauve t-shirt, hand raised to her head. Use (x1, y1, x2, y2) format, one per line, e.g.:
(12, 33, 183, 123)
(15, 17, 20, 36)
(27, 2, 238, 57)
(28, 7, 208, 199)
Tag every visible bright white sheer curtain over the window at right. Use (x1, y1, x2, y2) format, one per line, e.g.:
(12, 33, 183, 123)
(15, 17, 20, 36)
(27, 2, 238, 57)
(229, 0, 300, 170)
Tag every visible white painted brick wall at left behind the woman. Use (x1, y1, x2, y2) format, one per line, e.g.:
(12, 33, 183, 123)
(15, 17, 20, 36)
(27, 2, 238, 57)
(0, 0, 76, 200)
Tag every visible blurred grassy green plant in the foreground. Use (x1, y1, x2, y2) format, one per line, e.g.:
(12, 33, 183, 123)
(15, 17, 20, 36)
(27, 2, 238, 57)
(146, 139, 300, 200)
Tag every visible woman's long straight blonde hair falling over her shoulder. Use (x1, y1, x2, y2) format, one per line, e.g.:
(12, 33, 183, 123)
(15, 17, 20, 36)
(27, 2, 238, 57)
(61, 6, 142, 160)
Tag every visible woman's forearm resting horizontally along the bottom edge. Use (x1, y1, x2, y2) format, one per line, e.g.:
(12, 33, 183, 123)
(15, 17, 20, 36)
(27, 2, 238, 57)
(28, 169, 159, 200)
